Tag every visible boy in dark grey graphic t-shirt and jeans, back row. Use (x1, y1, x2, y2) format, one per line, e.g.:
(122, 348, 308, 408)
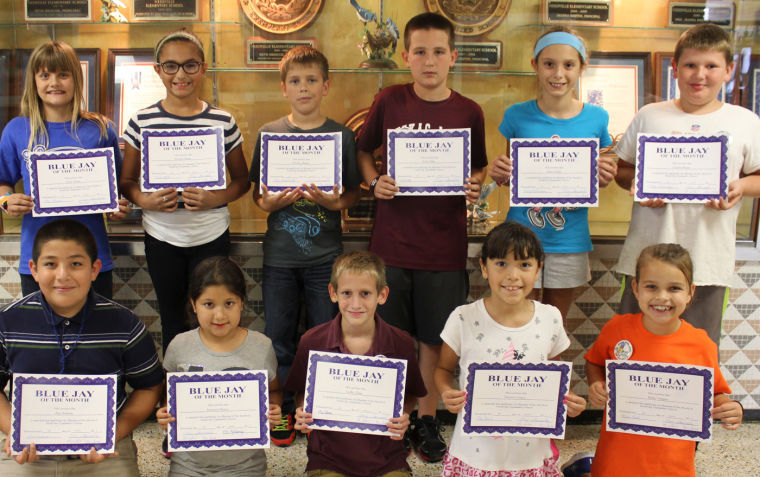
(250, 46, 361, 446)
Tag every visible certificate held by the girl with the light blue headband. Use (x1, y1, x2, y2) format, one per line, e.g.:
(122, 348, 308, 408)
(509, 138, 599, 207)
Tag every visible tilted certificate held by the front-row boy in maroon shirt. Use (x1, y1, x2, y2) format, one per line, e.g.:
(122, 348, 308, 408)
(304, 351, 406, 436)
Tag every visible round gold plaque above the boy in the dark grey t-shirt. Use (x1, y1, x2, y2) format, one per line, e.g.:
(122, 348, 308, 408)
(240, 0, 324, 34)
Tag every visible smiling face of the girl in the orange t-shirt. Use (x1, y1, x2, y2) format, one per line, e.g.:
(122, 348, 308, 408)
(632, 258, 694, 335)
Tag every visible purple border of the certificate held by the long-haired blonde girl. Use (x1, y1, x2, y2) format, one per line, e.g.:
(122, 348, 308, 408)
(29, 148, 119, 216)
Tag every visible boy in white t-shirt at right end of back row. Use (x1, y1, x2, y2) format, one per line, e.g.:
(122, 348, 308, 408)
(615, 24, 760, 344)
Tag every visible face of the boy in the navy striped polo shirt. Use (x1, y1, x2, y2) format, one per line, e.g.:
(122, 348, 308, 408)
(29, 239, 101, 318)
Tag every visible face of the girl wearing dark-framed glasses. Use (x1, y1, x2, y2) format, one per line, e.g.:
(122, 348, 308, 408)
(153, 40, 208, 102)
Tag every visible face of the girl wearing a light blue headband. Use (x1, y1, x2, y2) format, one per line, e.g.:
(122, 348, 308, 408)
(531, 44, 584, 98)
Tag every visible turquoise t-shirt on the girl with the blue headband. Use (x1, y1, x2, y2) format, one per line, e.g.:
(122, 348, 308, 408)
(499, 99, 612, 253)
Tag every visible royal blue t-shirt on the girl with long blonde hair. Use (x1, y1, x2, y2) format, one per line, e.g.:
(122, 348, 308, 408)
(0, 116, 121, 275)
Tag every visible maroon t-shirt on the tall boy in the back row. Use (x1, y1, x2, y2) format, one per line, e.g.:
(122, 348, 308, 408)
(357, 83, 488, 271)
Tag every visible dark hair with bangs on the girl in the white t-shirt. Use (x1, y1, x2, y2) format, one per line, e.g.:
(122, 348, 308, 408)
(480, 222, 544, 265)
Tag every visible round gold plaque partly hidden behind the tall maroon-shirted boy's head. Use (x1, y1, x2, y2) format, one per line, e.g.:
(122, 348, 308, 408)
(425, 0, 512, 36)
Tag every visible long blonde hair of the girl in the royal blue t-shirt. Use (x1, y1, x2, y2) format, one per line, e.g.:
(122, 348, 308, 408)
(21, 41, 108, 149)
